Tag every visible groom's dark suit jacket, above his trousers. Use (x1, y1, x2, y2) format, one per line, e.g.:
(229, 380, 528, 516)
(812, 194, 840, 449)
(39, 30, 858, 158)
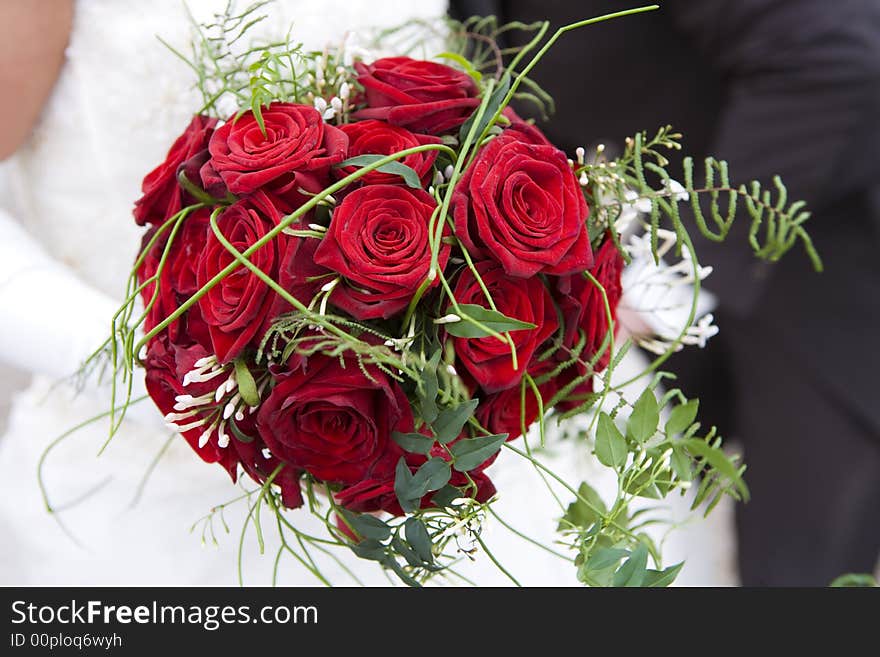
(452, 0, 880, 429)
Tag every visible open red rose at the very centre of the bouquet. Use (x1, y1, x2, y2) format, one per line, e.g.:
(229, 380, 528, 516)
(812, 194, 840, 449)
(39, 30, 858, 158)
(315, 185, 450, 319)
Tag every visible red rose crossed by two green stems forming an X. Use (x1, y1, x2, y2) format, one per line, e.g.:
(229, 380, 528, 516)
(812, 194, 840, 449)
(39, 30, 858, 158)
(196, 192, 287, 363)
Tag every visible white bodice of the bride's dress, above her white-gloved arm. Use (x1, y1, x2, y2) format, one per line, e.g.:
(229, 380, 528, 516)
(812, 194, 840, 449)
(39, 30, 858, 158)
(10, 0, 446, 298)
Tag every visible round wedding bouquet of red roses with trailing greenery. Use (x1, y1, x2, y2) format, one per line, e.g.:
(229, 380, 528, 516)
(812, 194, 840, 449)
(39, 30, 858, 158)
(82, 0, 815, 586)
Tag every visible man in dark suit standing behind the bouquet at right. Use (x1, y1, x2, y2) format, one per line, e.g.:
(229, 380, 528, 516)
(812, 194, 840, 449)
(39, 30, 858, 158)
(452, 0, 880, 586)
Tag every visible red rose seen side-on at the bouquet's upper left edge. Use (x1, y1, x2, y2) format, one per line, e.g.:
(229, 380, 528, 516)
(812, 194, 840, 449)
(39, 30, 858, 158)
(134, 114, 217, 226)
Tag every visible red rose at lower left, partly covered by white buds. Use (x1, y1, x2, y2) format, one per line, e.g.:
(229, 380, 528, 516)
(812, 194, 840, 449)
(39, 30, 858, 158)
(145, 335, 238, 481)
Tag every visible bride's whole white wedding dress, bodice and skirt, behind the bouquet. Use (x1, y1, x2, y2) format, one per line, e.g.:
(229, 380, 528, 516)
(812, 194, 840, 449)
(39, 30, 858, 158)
(0, 0, 733, 585)
